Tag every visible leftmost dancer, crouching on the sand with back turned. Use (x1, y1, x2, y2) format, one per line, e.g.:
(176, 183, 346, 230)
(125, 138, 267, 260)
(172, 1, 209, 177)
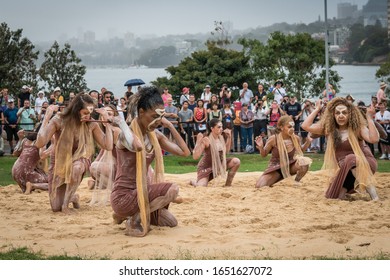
(12, 127, 52, 194)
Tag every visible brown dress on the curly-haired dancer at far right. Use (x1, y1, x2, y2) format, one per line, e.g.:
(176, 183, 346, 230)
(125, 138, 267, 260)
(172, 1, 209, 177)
(325, 140, 377, 198)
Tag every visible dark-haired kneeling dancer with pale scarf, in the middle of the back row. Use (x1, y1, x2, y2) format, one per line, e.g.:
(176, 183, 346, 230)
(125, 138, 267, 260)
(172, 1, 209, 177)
(190, 118, 240, 187)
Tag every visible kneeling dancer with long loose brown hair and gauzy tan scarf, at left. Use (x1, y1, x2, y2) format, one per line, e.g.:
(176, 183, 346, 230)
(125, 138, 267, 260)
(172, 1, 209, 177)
(36, 93, 113, 213)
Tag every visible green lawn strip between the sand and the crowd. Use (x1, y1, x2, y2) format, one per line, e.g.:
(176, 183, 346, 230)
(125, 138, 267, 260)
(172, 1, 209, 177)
(0, 153, 390, 186)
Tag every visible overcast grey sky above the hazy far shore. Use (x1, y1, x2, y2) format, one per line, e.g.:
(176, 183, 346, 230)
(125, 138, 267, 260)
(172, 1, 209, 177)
(0, 0, 368, 42)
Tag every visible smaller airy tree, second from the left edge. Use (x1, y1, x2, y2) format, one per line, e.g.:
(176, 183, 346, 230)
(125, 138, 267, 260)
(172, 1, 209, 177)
(39, 41, 87, 97)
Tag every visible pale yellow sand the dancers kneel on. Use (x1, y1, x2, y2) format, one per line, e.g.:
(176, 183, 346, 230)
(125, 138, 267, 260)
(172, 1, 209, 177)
(0, 172, 390, 259)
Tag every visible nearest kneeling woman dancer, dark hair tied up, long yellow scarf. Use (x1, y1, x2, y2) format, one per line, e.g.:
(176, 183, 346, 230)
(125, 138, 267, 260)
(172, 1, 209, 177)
(111, 87, 190, 236)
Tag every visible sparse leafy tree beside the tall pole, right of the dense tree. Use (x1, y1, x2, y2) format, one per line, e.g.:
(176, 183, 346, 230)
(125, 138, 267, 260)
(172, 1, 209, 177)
(240, 32, 341, 99)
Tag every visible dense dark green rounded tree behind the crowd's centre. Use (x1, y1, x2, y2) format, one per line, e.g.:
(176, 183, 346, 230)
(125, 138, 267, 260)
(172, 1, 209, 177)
(152, 43, 252, 100)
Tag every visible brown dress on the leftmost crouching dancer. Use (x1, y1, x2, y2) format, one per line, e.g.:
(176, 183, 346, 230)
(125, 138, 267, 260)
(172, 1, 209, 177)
(12, 141, 48, 192)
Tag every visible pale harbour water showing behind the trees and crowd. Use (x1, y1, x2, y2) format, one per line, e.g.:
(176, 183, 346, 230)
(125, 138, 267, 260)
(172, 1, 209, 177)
(85, 65, 379, 104)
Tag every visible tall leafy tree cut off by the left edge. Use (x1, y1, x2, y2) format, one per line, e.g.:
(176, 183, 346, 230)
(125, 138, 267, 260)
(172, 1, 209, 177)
(0, 22, 39, 94)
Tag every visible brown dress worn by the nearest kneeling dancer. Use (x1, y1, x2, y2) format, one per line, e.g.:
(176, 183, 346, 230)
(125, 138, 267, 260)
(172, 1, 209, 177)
(111, 148, 175, 226)
